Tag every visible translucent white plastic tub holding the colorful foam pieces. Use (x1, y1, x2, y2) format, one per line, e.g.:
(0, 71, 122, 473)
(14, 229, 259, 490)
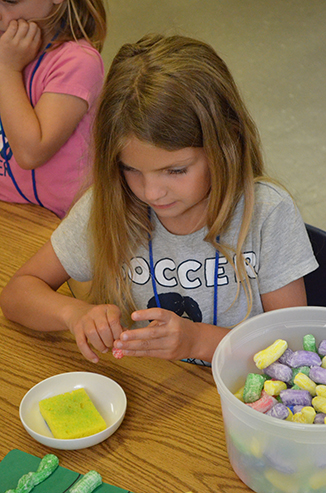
(212, 307, 326, 493)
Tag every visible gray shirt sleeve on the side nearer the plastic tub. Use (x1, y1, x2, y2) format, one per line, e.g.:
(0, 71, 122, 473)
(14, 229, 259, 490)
(258, 188, 318, 294)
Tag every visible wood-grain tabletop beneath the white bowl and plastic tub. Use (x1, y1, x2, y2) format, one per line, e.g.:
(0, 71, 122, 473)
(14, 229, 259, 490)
(0, 202, 251, 493)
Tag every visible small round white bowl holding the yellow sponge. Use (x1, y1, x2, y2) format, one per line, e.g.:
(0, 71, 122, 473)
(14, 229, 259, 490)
(19, 371, 127, 450)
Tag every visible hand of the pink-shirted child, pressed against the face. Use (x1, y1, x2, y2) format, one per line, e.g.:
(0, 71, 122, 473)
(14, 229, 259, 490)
(0, 19, 41, 73)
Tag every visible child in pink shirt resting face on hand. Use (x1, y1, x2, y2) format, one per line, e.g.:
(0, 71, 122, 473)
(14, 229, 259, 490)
(0, 0, 106, 217)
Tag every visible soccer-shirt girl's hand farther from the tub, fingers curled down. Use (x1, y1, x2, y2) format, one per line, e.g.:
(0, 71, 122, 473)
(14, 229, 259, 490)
(67, 304, 123, 363)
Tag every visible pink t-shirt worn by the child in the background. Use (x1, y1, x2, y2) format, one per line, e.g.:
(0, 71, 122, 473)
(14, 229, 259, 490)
(0, 40, 104, 217)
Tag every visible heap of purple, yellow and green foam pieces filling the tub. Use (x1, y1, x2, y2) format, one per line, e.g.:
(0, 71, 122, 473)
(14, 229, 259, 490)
(236, 334, 326, 424)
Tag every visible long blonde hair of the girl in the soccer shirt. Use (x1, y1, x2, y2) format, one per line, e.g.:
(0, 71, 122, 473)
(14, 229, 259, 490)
(90, 35, 264, 320)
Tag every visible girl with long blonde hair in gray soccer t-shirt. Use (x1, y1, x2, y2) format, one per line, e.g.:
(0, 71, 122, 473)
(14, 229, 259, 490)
(1, 35, 317, 364)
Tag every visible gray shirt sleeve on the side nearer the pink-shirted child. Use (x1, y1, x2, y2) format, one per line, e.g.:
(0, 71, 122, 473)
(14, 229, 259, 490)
(51, 191, 93, 282)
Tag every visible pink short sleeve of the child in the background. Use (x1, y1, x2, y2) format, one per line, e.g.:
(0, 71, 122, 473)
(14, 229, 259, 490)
(43, 42, 104, 106)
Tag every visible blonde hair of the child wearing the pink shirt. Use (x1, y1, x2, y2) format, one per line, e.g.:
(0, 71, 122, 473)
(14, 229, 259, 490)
(37, 0, 106, 52)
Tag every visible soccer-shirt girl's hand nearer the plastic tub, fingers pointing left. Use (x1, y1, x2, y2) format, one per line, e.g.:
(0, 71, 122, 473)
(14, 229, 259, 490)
(114, 308, 200, 360)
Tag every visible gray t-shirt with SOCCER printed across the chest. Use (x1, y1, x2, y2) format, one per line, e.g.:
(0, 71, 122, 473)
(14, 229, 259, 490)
(51, 182, 318, 334)
